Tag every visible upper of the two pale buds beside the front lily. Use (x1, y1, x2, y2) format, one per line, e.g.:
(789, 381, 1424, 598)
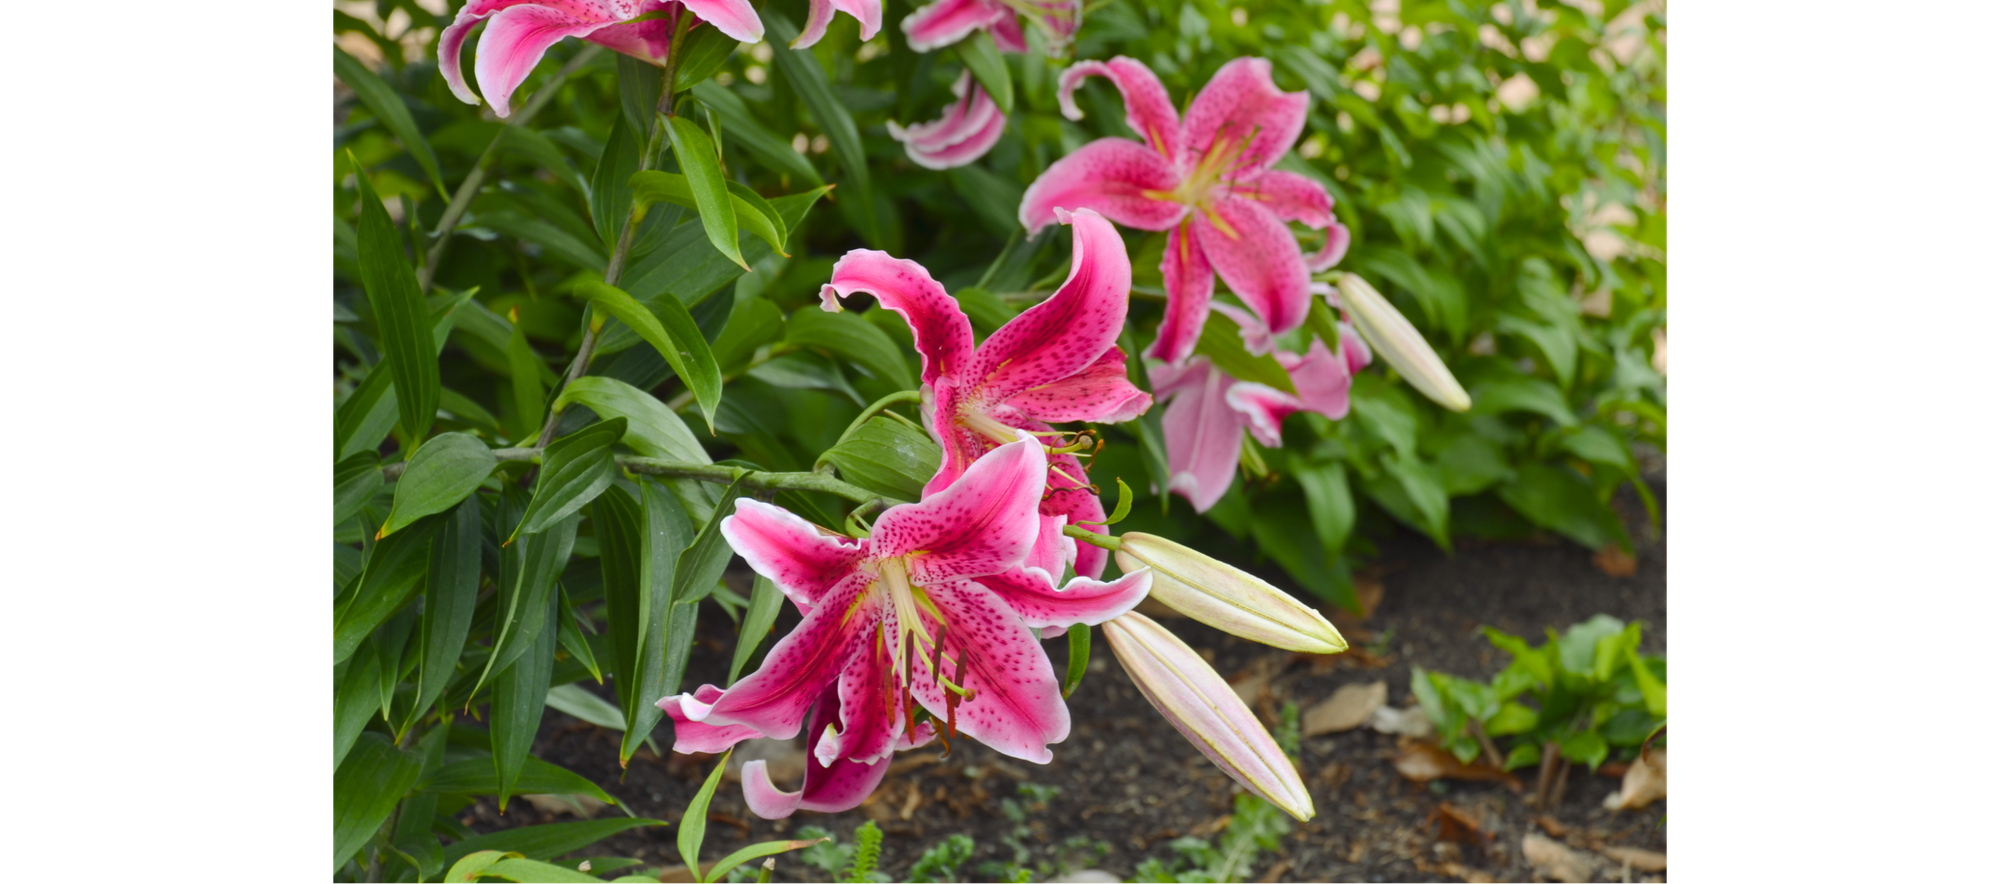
(1116, 532, 1348, 654)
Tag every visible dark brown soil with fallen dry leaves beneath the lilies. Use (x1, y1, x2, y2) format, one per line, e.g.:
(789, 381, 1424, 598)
(462, 468, 1670, 884)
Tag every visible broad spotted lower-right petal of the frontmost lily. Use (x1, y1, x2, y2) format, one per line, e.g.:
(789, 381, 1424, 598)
(910, 580, 1070, 764)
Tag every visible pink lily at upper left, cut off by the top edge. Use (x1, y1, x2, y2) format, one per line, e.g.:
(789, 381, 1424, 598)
(438, 0, 760, 118)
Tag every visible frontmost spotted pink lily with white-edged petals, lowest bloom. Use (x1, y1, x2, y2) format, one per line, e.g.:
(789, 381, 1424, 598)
(660, 434, 1152, 818)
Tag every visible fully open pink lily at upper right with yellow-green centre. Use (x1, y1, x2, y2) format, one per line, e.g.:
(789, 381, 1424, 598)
(1020, 56, 1348, 366)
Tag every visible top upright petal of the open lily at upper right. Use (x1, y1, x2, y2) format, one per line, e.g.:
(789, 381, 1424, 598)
(1180, 58, 1312, 178)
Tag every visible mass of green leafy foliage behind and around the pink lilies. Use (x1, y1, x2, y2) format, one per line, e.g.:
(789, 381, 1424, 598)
(328, 0, 1668, 880)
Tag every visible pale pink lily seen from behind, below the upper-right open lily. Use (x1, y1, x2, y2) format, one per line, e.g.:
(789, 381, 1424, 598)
(1148, 324, 1372, 512)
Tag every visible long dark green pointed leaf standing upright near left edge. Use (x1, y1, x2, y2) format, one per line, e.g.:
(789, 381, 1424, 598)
(354, 154, 440, 448)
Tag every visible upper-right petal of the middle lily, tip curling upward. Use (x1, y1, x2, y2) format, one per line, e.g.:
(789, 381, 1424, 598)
(968, 208, 1132, 400)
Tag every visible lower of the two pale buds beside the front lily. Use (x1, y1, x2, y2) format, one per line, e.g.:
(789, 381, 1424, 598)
(1102, 612, 1312, 822)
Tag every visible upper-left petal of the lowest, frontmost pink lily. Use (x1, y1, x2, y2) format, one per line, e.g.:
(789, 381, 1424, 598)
(722, 498, 868, 610)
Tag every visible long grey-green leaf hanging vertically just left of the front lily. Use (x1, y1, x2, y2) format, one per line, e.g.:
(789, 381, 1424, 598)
(618, 482, 696, 766)
